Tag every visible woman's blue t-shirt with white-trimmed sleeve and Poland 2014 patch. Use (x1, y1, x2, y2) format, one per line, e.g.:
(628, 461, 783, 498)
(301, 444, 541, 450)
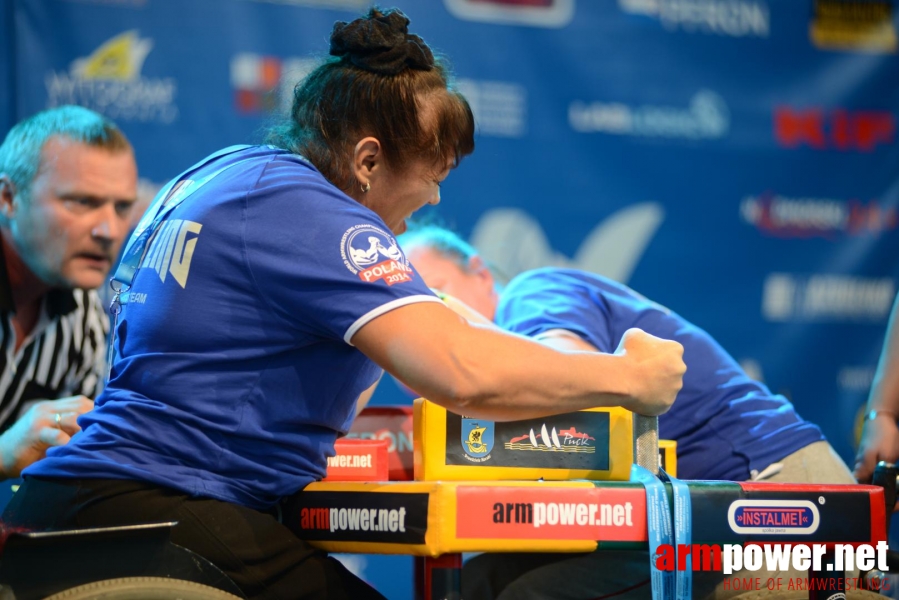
(25, 146, 440, 508)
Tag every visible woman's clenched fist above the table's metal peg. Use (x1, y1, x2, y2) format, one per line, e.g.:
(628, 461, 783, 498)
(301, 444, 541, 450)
(615, 329, 687, 416)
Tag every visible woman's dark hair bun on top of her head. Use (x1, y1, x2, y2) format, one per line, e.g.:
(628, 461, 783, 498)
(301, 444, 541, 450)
(331, 8, 434, 75)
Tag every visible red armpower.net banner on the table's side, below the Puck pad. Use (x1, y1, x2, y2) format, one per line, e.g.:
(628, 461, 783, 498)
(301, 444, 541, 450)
(456, 485, 646, 542)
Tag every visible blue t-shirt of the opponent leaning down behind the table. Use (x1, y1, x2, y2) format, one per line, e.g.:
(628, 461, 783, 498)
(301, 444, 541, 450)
(496, 268, 824, 481)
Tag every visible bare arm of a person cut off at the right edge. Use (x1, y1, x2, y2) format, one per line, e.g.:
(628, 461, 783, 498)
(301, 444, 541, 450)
(854, 296, 899, 482)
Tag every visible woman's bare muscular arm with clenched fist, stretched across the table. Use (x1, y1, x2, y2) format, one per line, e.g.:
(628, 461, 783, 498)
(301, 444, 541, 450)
(352, 303, 685, 421)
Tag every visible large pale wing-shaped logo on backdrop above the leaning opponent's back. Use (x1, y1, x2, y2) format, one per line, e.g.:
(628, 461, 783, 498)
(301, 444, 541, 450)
(470, 202, 665, 283)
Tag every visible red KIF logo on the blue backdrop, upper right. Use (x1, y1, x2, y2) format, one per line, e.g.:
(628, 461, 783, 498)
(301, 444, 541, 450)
(774, 106, 896, 152)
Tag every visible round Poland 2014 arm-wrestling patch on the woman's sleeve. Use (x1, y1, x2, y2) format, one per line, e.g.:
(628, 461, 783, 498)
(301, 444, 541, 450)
(340, 224, 414, 285)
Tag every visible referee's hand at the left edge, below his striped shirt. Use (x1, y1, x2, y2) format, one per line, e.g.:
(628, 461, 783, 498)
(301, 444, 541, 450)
(0, 396, 94, 478)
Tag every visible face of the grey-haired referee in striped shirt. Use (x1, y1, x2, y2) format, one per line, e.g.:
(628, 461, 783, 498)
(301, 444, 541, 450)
(10, 137, 137, 289)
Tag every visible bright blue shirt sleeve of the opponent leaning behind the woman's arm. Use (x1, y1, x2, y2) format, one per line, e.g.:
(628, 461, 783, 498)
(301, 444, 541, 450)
(496, 269, 617, 352)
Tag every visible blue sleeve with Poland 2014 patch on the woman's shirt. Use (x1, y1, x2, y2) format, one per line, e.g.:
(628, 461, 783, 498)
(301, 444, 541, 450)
(245, 158, 440, 343)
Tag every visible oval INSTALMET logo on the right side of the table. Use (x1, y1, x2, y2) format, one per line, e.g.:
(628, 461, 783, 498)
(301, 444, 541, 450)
(727, 500, 821, 535)
